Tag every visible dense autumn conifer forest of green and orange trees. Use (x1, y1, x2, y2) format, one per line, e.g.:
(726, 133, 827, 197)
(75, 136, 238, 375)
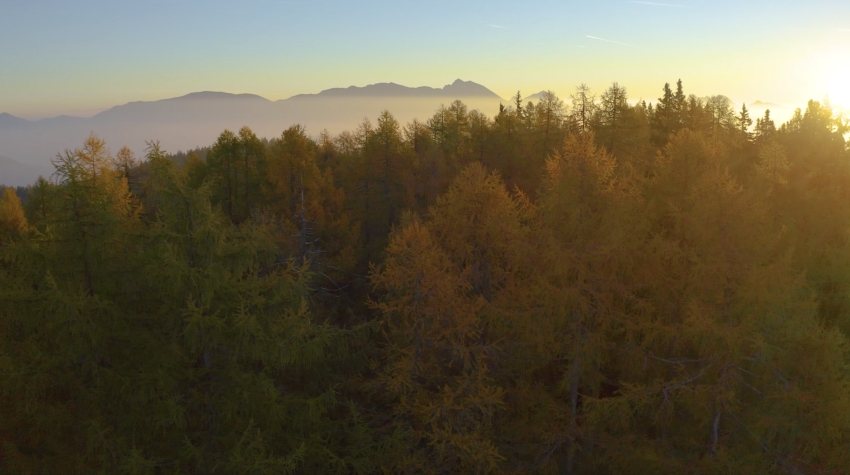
(0, 81, 850, 475)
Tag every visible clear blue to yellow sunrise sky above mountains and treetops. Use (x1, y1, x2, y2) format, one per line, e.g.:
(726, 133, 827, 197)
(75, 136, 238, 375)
(0, 0, 850, 119)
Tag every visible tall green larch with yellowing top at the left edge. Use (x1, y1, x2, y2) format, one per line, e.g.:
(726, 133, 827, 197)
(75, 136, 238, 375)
(0, 135, 138, 473)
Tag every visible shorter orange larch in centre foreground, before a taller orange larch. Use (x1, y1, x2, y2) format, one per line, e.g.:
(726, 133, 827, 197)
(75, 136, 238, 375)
(372, 221, 502, 473)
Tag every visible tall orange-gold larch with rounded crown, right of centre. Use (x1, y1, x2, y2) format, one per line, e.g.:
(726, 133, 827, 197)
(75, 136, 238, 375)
(526, 133, 640, 473)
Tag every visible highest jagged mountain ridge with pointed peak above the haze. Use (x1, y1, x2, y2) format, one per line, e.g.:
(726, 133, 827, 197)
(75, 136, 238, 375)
(288, 79, 501, 100)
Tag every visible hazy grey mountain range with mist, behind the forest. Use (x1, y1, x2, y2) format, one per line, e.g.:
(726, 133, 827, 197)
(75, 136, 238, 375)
(0, 79, 505, 185)
